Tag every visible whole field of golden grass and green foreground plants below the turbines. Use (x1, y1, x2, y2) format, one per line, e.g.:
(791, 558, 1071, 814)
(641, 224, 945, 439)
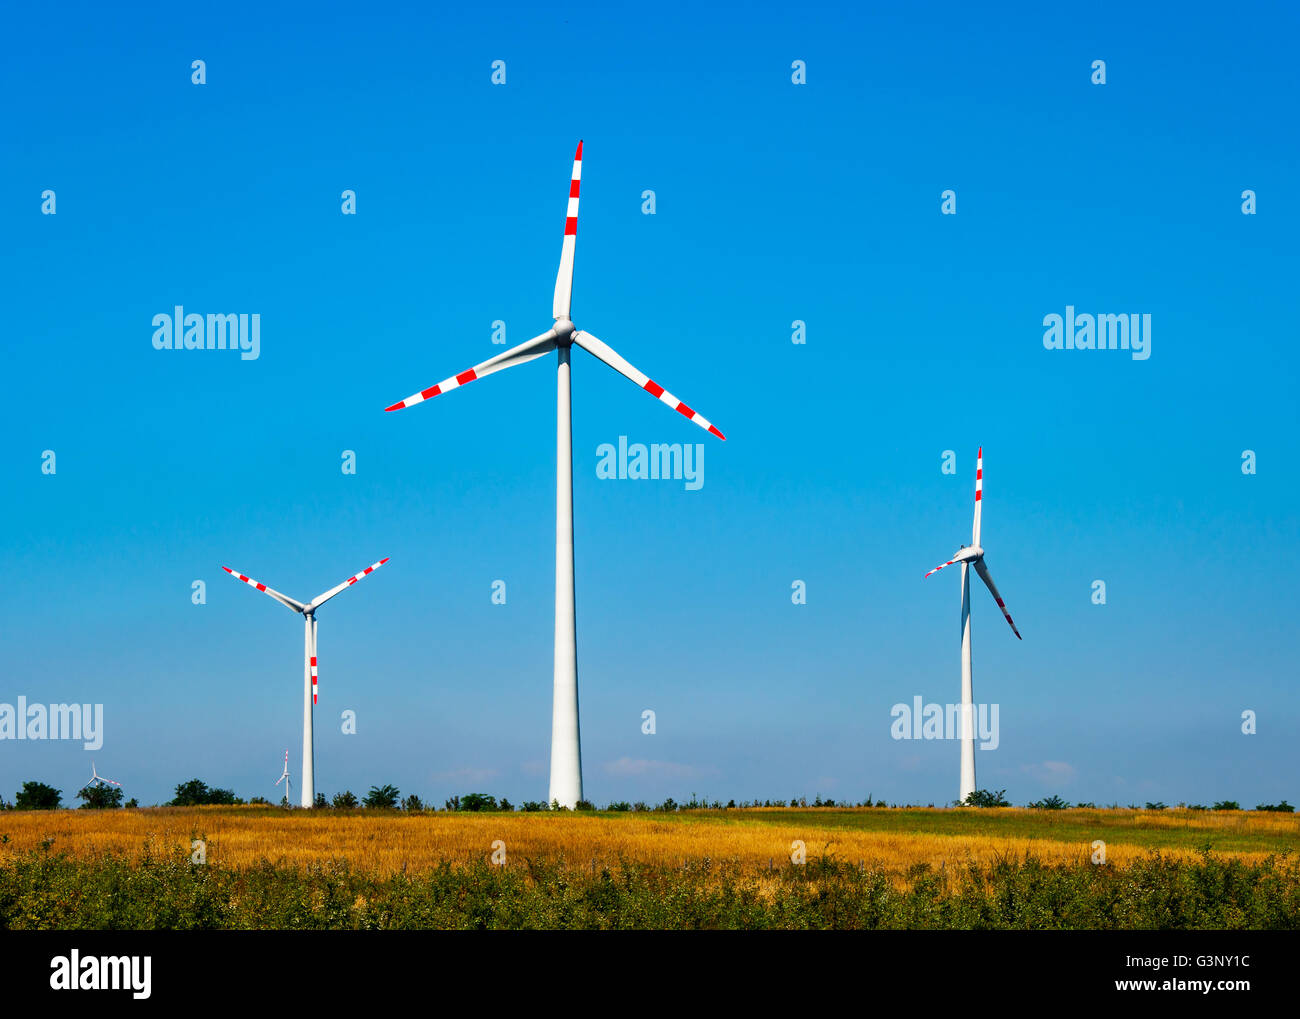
(0, 807, 1300, 928)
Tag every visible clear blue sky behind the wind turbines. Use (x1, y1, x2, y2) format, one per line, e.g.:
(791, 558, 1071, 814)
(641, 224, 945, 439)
(0, 4, 1300, 806)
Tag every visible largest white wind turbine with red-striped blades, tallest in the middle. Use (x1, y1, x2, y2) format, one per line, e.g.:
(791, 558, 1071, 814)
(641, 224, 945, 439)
(385, 142, 725, 808)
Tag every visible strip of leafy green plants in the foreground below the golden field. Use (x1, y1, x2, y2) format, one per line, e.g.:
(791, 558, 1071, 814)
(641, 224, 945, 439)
(0, 850, 1300, 929)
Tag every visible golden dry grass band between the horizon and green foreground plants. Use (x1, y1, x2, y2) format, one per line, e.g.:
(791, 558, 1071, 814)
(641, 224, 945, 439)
(0, 807, 1300, 875)
